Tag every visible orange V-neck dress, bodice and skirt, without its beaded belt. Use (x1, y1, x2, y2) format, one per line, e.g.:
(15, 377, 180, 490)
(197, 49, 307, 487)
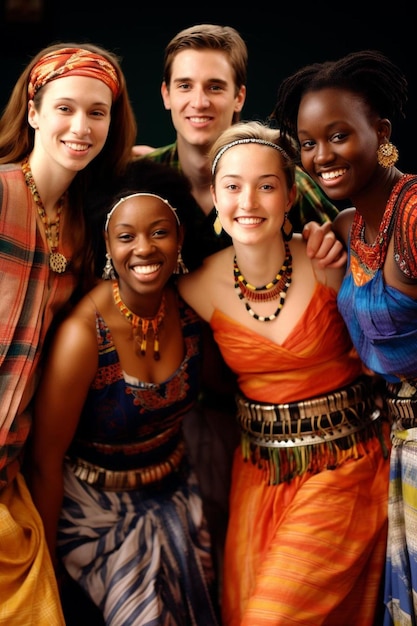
(210, 284, 389, 626)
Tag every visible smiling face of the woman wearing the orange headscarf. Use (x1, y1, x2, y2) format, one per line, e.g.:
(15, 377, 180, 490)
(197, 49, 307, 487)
(28, 76, 112, 173)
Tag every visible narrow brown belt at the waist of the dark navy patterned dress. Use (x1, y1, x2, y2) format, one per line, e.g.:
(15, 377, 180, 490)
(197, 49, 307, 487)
(66, 441, 185, 491)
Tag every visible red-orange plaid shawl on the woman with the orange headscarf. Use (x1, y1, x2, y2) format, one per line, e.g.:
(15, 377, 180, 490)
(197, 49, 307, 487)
(0, 164, 75, 489)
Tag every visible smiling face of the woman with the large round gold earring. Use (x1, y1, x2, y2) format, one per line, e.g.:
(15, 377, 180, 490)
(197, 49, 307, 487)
(298, 88, 389, 200)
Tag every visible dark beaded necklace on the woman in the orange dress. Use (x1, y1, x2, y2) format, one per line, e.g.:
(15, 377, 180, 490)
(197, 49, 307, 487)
(233, 242, 292, 322)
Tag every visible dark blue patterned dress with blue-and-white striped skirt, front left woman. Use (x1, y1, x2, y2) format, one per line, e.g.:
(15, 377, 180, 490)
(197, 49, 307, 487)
(58, 300, 218, 626)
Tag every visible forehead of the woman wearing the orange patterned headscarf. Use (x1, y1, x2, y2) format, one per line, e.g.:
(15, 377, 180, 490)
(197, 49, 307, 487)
(42, 76, 112, 106)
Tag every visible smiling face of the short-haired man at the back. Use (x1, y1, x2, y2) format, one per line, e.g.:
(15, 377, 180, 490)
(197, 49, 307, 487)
(161, 49, 246, 146)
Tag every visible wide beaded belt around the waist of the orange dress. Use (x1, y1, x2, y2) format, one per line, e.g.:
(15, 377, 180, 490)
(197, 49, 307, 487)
(236, 381, 380, 448)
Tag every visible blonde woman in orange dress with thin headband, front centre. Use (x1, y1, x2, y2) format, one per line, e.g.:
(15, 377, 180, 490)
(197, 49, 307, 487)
(179, 122, 389, 626)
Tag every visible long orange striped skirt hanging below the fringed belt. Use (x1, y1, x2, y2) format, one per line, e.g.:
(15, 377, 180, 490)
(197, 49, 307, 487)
(222, 437, 388, 626)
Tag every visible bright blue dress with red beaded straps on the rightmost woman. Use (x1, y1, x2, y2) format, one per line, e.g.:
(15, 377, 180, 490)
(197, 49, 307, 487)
(338, 174, 417, 626)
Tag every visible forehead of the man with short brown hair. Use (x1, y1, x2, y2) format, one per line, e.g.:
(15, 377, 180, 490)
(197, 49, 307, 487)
(171, 49, 234, 83)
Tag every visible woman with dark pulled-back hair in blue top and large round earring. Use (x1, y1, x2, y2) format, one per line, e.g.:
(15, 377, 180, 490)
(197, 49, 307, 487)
(275, 50, 417, 626)
